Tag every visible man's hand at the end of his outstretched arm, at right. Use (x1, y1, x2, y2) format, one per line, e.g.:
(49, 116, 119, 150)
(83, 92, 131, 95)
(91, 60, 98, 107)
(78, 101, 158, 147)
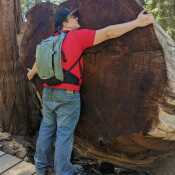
(136, 11, 154, 27)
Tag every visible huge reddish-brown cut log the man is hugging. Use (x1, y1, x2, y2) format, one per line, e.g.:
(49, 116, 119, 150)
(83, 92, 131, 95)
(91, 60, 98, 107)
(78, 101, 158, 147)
(21, 0, 175, 168)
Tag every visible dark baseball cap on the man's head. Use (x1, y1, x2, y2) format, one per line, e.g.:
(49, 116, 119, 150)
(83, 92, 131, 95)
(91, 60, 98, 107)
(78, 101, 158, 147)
(55, 8, 79, 28)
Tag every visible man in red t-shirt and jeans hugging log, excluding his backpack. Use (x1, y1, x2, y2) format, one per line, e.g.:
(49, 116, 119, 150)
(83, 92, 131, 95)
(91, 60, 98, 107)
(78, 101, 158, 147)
(27, 9, 154, 175)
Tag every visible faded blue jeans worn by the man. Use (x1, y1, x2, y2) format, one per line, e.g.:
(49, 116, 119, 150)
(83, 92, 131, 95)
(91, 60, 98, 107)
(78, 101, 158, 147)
(34, 88, 80, 175)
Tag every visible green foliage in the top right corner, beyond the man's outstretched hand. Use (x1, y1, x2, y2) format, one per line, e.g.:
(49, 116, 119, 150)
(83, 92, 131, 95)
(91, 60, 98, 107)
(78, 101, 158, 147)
(146, 0, 175, 40)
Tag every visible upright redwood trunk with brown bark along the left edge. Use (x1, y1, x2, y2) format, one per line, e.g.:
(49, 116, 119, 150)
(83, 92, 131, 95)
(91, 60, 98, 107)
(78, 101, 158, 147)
(0, 0, 39, 134)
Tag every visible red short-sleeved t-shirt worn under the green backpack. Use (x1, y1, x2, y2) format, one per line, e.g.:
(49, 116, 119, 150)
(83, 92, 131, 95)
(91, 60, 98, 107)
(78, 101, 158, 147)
(44, 29, 96, 91)
